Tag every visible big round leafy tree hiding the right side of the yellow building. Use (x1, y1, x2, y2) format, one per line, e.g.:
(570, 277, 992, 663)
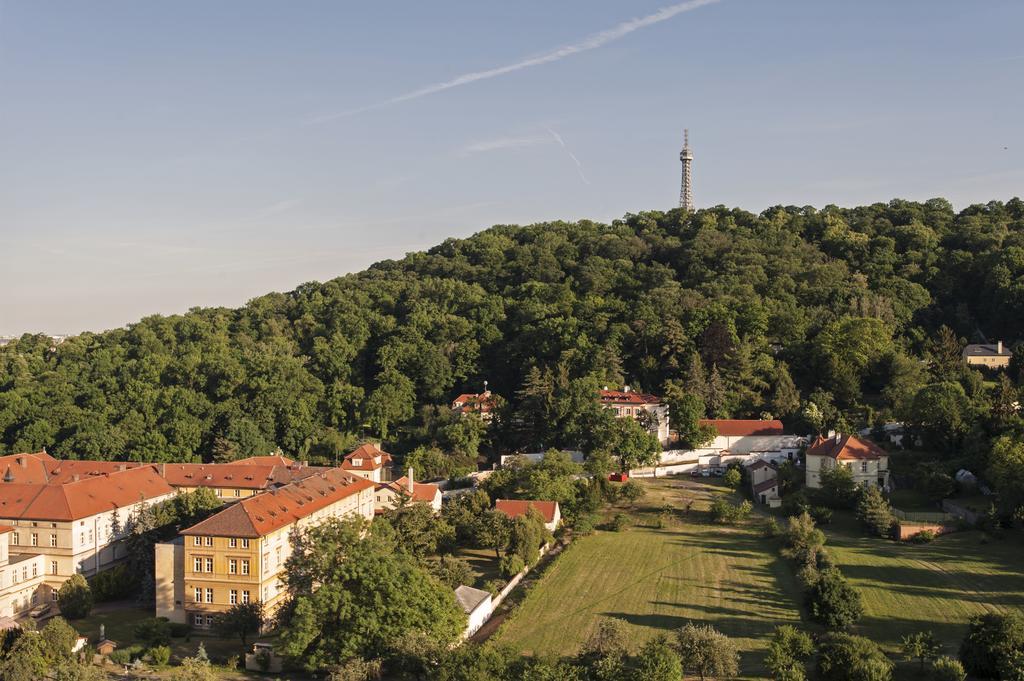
(279, 518, 466, 671)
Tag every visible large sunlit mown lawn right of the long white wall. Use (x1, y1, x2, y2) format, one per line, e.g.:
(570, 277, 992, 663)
(496, 477, 800, 675)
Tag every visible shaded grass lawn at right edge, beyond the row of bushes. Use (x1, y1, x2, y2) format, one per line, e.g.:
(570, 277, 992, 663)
(825, 523, 1024, 654)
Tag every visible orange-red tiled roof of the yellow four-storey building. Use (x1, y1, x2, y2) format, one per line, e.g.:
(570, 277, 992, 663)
(181, 468, 374, 539)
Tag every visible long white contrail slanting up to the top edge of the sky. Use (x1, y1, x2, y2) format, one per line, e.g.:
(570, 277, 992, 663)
(307, 0, 719, 123)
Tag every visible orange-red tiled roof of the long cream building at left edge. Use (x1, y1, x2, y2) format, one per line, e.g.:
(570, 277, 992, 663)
(0, 466, 174, 520)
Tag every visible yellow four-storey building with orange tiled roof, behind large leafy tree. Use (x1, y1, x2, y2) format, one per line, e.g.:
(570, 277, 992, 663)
(156, 469, 374, 629)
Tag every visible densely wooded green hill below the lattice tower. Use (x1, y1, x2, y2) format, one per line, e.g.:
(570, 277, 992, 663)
(0, 199, 1024, 461)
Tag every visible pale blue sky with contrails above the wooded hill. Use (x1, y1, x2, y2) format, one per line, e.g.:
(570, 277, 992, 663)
(0, 0, 1024, 336)
